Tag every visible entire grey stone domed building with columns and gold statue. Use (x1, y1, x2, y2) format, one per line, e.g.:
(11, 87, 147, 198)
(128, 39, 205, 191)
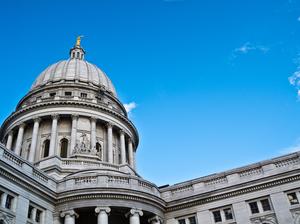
(0, 39, 300, 224)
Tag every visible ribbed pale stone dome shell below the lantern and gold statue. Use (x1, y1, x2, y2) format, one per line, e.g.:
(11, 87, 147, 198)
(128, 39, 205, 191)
(31, 58, 117, 96)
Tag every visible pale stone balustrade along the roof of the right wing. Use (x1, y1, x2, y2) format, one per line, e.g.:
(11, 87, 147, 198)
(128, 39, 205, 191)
(160, 152, 300, 202)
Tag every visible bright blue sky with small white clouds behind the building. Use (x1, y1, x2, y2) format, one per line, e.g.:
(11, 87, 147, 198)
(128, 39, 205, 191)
(0, 0, 300, 185)
